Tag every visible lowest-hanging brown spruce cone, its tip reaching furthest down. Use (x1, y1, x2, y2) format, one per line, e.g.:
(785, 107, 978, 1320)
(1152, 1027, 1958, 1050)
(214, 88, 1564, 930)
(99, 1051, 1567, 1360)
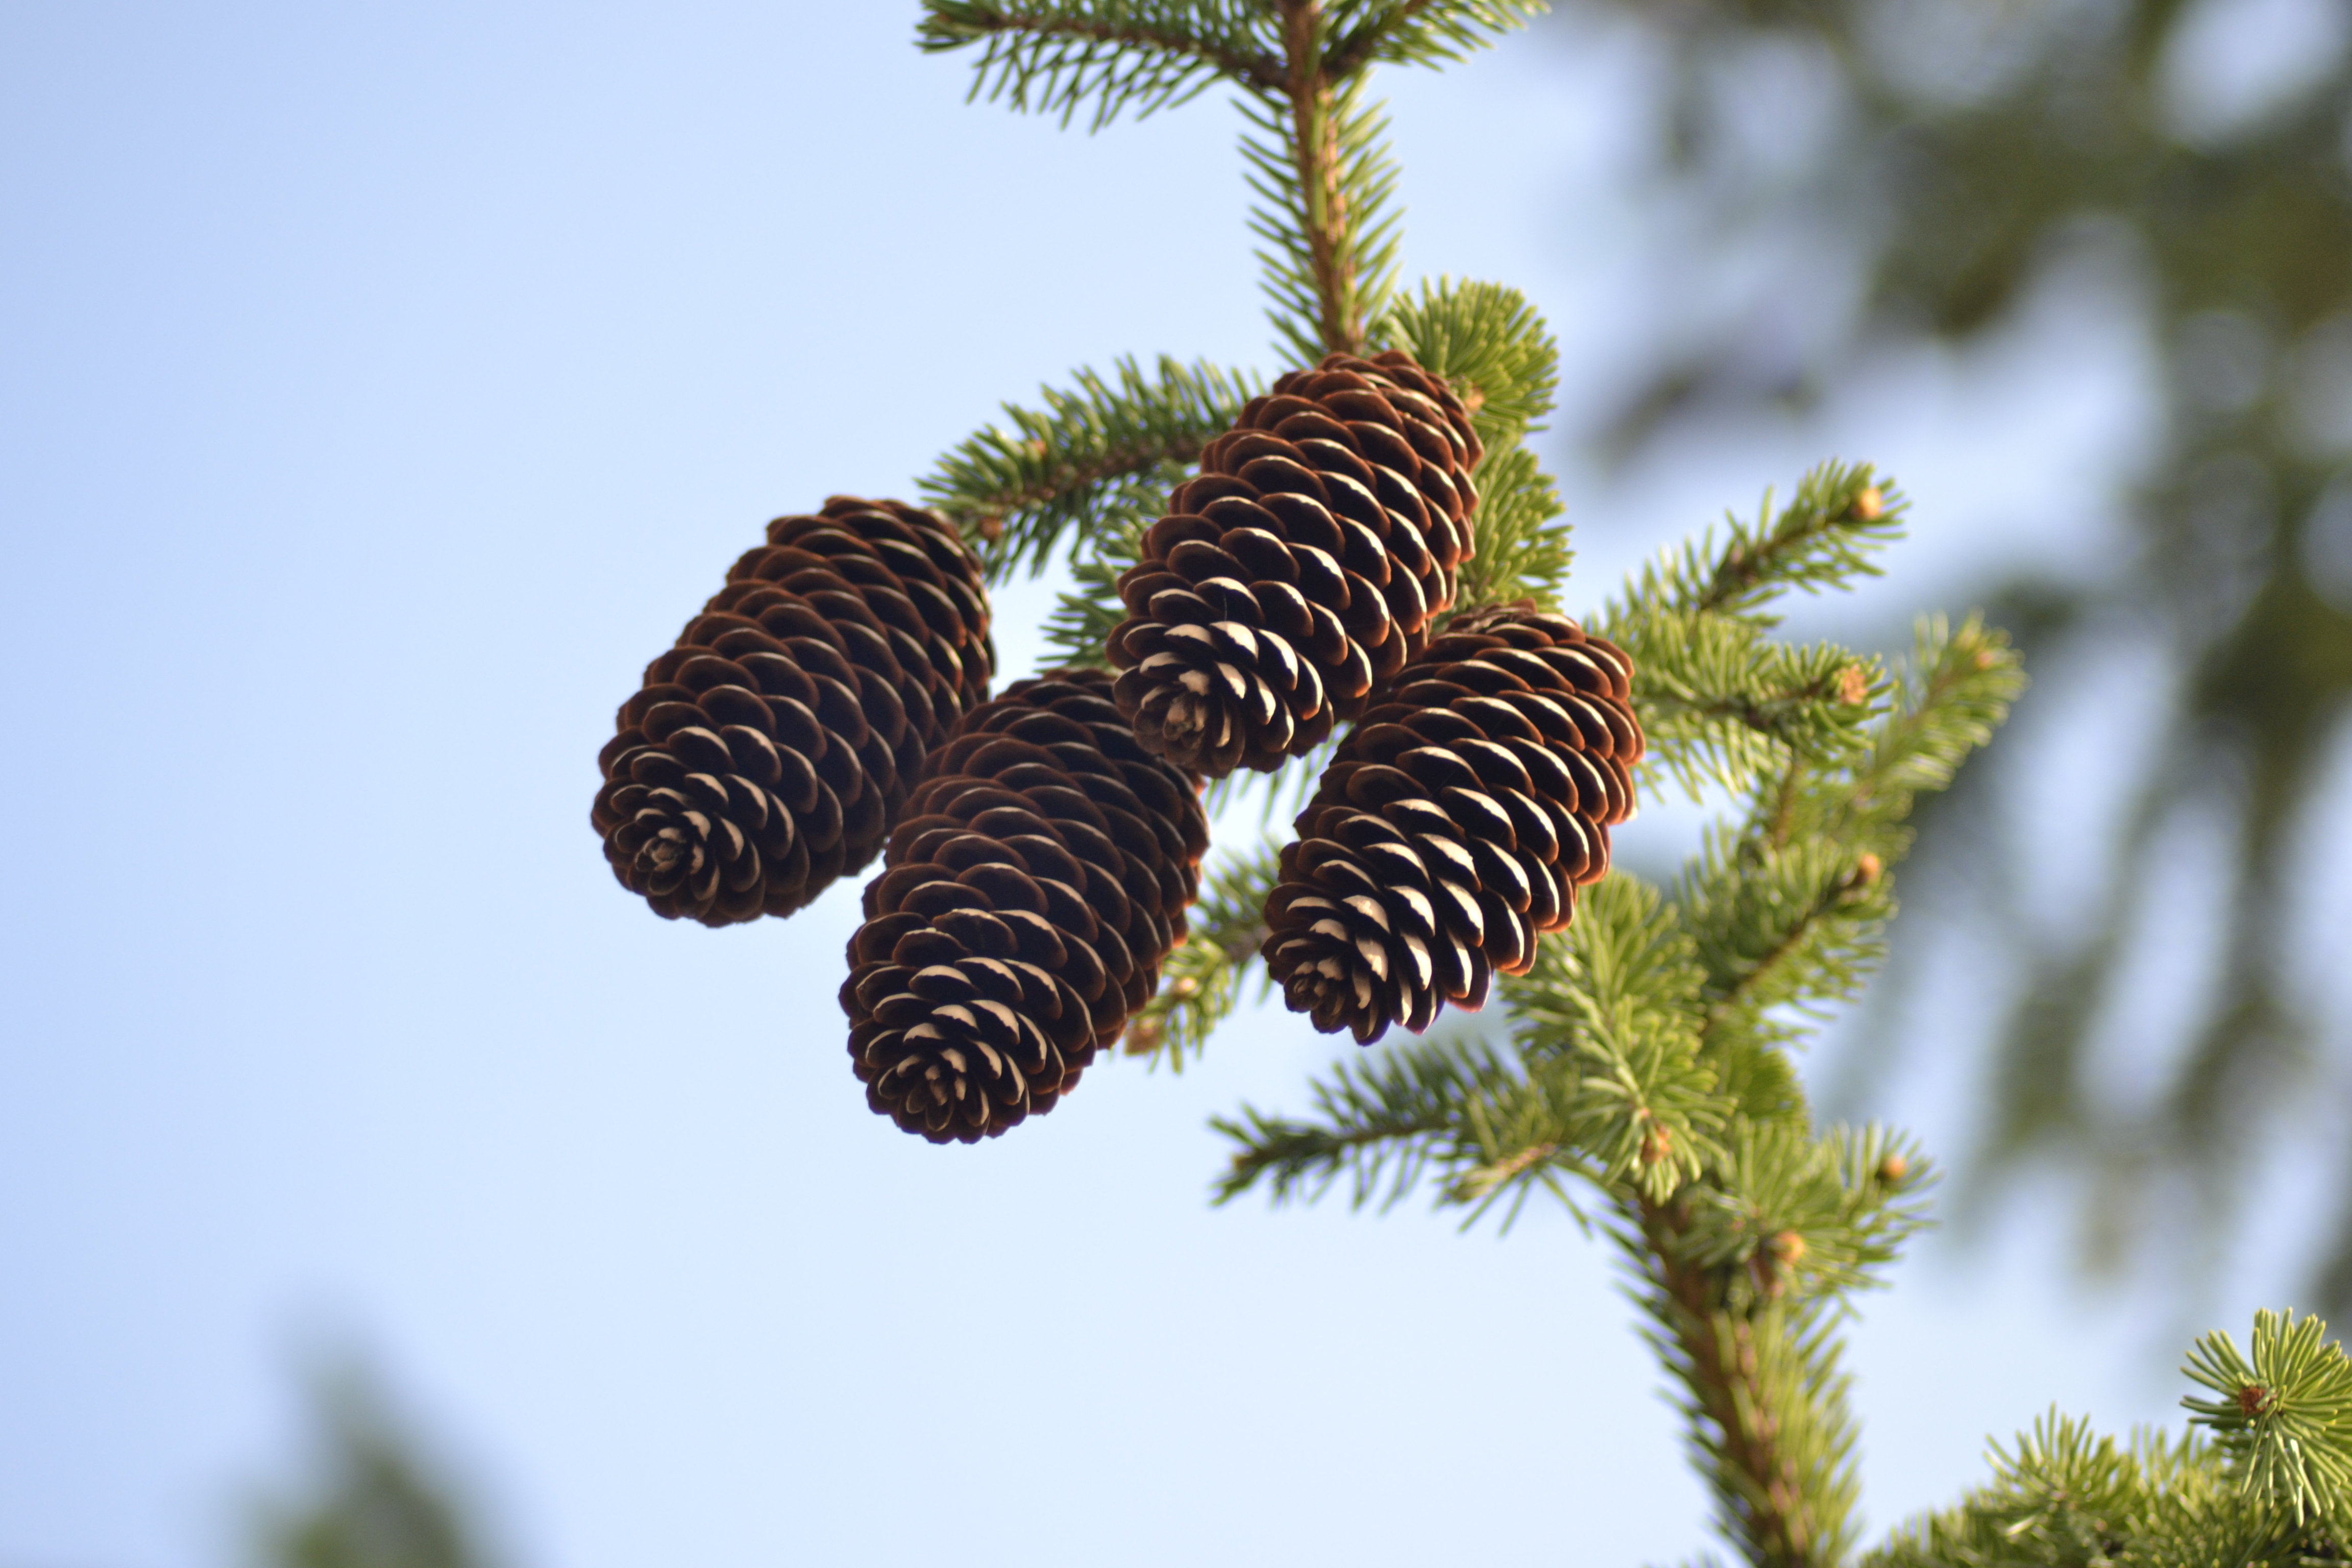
(842, 670, 1209, 1142)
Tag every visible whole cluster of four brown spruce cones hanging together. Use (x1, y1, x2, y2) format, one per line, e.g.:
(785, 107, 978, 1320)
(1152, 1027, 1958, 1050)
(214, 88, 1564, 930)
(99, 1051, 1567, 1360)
(591, 353, 1641, 1142)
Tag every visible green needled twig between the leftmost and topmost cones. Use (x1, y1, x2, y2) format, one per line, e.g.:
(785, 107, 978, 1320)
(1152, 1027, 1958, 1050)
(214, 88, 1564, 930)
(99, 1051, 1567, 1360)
(920, 355, 1261, 574)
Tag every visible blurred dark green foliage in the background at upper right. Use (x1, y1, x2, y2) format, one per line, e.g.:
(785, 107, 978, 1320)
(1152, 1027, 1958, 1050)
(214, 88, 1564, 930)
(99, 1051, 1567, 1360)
(1571, 0, 2352, 1307)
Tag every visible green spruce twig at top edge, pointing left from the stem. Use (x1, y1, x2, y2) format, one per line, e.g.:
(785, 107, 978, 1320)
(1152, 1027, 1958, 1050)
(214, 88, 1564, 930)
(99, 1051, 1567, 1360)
(915, 0, 1284, 129)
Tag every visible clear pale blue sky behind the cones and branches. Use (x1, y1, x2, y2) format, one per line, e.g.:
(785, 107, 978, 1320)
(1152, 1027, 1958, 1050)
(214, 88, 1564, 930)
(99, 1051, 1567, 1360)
(0, 0, 2352, 1568)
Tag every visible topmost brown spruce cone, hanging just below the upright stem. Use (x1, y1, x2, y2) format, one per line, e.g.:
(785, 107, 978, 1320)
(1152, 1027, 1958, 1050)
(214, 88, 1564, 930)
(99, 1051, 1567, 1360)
(1106, 350, 1484, 778)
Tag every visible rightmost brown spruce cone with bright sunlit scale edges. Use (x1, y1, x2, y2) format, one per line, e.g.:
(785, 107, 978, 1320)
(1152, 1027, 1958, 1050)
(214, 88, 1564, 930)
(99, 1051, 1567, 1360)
(1263, 606, 1641, 1044)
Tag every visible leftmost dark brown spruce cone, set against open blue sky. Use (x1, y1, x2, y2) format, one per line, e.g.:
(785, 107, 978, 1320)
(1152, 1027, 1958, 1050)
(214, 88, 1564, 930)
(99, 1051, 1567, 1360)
(591, 496, 995, 926)
